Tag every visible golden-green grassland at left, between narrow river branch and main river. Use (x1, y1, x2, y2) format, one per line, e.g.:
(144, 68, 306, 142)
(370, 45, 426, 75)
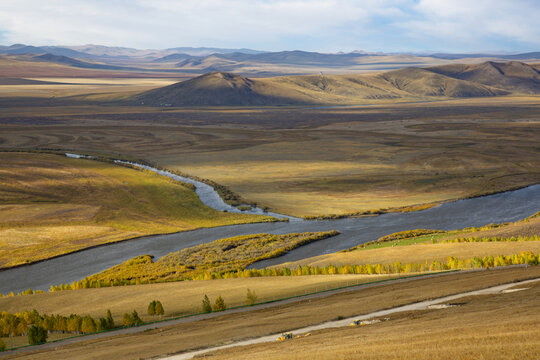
(0, 152, 274, 267)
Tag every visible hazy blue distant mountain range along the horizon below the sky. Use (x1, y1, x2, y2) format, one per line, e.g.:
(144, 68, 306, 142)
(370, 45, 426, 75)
(0, 44, 540, 80)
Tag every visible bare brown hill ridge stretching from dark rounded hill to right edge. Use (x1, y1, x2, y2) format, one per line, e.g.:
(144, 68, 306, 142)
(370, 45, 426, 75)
(132, 61, 540, 106)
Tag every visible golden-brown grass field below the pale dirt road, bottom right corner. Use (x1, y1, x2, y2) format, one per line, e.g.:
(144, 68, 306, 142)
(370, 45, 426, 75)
(205, 281, 540, 360)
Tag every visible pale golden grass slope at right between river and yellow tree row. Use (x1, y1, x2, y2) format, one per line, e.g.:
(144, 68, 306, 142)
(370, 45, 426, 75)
(277, 216, 540, 268)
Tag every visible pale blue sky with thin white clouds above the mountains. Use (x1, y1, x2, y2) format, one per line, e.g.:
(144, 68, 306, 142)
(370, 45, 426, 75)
(0, 0, 540, 53)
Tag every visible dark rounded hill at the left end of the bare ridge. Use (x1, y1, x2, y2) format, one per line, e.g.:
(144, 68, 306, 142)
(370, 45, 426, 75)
(134, 71, 309, 106)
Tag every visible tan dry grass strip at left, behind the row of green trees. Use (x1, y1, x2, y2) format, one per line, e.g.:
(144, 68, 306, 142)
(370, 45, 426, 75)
(0, 275, 392, 322)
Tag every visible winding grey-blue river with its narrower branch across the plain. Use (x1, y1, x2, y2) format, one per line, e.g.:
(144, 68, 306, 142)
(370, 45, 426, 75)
(0, 158, 540, 294)
